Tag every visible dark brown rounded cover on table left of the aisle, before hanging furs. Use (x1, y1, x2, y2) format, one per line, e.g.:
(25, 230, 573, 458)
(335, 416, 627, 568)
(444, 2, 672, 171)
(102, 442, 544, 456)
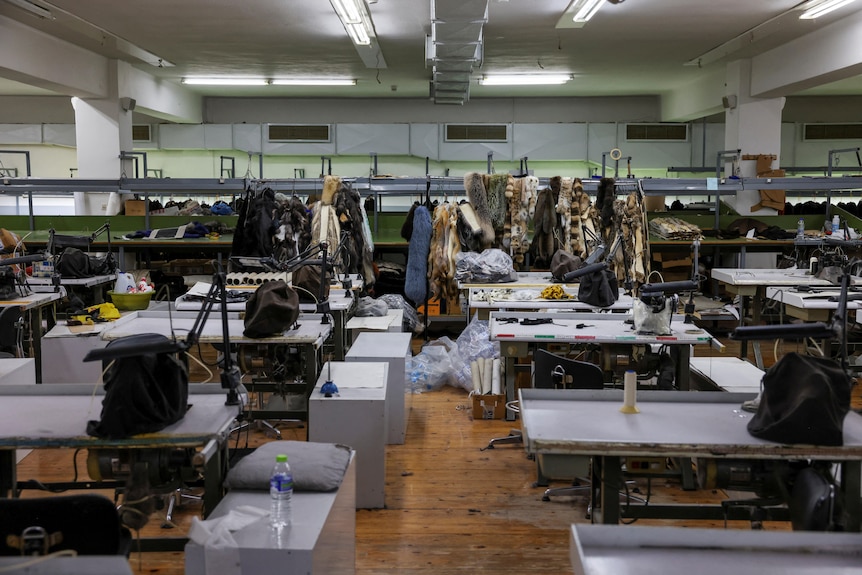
(242, 280, 299, 338)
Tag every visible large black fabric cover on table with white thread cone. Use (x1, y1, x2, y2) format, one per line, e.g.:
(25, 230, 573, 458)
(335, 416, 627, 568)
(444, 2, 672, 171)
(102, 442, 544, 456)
(748, 353, 851, 445)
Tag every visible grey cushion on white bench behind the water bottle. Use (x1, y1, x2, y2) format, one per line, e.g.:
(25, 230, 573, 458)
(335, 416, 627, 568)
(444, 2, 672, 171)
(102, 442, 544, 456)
(225, 441, 350, 491)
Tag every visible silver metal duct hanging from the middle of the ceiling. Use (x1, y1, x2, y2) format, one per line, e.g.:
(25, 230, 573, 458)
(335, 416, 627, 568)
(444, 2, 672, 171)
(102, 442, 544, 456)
(425, 0, 489, 105)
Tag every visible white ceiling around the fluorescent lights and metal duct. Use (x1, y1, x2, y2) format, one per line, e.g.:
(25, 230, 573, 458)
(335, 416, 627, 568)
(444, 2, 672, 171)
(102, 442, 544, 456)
(0, 0, 862, 99)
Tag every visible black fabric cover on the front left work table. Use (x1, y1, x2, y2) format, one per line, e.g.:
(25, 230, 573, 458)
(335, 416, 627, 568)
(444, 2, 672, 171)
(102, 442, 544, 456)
(87, 333, 189, 439)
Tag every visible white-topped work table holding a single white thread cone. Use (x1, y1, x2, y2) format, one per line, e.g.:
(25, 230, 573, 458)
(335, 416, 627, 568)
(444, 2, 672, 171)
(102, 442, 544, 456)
(519, 388, 862, 531)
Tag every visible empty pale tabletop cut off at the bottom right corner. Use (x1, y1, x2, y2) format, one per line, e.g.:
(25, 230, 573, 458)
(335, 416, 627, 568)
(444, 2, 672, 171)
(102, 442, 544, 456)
(570, 525, 862, 575)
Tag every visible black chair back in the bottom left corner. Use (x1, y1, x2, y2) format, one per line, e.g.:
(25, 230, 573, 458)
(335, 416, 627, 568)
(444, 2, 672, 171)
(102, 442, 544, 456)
(0, 493, 132, 557)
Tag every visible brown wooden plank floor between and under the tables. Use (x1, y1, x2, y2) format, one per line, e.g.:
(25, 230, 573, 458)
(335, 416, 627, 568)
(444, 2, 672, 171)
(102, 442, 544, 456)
(8, 336, 858, 575)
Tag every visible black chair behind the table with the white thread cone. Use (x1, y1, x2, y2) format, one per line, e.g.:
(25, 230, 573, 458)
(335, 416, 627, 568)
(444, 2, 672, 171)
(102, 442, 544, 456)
(533, 349, 605, 501)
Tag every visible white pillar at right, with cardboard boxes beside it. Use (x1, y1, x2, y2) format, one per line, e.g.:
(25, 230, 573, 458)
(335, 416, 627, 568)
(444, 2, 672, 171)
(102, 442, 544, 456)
(724, 60, 785, 215)
